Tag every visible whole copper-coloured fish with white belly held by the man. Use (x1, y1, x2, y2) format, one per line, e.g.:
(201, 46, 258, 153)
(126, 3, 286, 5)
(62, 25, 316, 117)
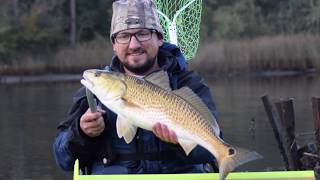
(81, 70, 261, 179)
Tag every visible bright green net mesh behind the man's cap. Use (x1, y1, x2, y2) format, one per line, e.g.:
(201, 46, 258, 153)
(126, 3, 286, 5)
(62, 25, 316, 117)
(155, 0, 202, 60)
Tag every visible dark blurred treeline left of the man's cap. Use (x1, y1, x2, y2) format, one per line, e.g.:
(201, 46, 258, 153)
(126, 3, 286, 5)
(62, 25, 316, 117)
(0, 0, 112, 63)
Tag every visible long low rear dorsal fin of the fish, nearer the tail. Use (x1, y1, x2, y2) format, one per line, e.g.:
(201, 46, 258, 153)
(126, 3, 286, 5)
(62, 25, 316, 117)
(172, 87, 220, 136)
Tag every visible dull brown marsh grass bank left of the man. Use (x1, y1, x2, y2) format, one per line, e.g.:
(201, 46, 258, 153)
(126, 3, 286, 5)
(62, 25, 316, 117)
(0, 37, 113, 75)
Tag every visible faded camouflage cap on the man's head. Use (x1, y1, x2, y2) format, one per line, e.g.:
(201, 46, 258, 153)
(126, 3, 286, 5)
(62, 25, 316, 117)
(110, 0, 163, 37)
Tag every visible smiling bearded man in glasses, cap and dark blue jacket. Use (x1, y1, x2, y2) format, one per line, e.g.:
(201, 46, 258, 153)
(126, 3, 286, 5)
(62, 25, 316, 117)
(54, 0, 216, 174)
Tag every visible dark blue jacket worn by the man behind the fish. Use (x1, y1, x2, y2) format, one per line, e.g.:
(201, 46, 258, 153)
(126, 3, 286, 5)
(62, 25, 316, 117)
(53, 43, 217, 174)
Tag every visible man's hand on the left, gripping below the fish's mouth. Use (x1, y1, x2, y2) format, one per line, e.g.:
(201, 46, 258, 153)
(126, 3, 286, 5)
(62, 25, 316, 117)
(80, 109, 105, 137)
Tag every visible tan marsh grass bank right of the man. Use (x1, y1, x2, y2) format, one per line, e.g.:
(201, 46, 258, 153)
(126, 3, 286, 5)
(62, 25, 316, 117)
(190, 35, 320, 74)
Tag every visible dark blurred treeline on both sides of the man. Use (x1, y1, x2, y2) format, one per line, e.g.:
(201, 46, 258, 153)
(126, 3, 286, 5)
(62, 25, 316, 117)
(0, 0, 320, 73)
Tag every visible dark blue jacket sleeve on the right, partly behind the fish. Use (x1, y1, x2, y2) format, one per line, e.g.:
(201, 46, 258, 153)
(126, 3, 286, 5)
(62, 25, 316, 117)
(178, 71, 221, 162)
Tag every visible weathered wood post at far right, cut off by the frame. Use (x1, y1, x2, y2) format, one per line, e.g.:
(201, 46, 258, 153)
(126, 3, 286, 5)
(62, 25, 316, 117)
(312, 97, 320, 180)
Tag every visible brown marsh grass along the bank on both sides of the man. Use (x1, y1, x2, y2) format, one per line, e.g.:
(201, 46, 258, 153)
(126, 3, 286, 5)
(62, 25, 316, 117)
(0, 35, 320, 75)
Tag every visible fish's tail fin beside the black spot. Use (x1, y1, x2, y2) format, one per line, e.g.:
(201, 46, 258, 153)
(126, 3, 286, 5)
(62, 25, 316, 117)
(218, 147, 262, 180)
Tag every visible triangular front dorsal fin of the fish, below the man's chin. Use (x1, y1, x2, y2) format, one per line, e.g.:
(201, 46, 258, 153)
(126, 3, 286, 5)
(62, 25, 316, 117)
(144, 70, 171, 91)
